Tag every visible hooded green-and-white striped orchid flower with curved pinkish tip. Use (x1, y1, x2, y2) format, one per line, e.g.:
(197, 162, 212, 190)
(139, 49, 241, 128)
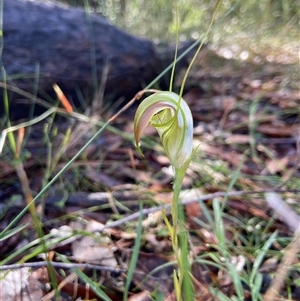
(134, 91, 193, 168)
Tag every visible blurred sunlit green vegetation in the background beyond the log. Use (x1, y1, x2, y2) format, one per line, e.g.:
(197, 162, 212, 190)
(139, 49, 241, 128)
(61, 0, 300, 63)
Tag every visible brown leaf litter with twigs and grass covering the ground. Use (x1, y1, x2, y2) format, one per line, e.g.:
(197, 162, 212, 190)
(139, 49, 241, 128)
(0, 45, 300, 301)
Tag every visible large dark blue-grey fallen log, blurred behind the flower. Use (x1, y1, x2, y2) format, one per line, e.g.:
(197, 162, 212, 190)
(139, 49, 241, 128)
(0, 0, 195, 118)
